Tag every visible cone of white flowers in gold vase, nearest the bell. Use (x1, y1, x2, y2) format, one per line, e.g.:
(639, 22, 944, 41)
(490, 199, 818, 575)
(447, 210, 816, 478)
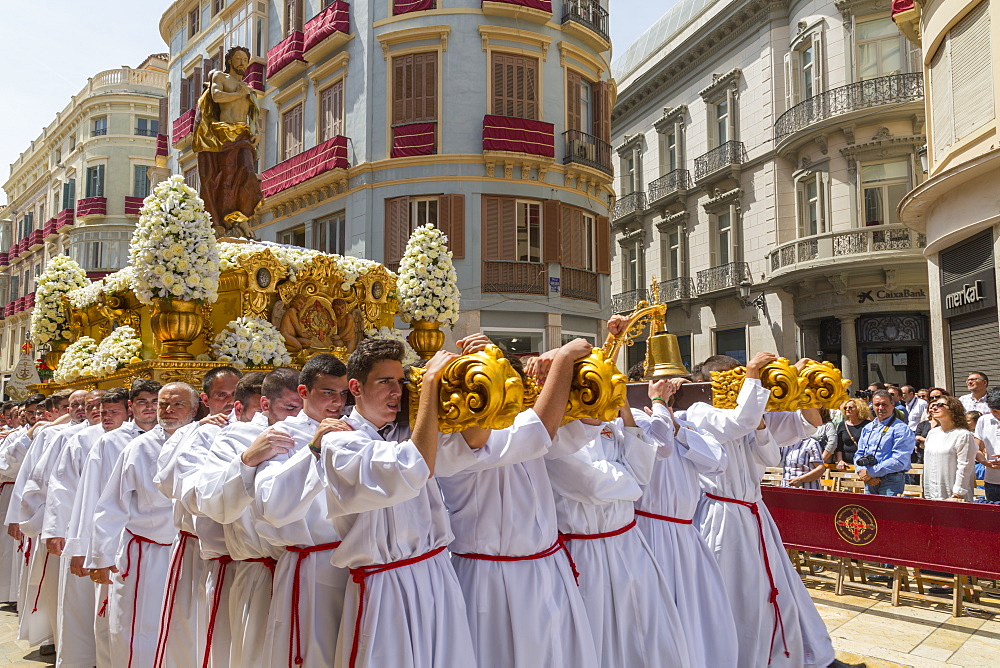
(396, 225, 460, 326)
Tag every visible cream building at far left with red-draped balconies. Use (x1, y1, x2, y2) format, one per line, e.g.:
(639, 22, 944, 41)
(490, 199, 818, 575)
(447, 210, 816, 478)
(0, 54, 167, 392)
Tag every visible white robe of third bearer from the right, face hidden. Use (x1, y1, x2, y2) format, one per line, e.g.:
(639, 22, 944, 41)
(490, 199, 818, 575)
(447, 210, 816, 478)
(545, 421, 690, 668)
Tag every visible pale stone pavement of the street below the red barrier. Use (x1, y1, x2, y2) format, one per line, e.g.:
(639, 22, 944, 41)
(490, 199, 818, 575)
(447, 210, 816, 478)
(0, 582, 1000, 668)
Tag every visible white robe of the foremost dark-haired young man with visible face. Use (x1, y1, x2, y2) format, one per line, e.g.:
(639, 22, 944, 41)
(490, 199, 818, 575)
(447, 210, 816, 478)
(314, 410, 479, 668)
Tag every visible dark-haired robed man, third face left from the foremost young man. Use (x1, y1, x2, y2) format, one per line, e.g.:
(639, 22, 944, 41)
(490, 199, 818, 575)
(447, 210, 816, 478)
(185, 368, 302, 668)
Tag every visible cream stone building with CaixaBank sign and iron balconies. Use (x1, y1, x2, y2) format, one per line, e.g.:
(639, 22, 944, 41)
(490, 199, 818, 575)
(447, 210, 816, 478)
(612, 0, 931, 388)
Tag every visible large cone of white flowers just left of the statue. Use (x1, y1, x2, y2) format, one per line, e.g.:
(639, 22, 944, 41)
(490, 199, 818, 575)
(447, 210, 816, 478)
(129, 174, 219, 304)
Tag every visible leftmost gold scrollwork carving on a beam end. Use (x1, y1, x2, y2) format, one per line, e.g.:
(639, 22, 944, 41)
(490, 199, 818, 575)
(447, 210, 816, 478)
(408, 345, 525, 434)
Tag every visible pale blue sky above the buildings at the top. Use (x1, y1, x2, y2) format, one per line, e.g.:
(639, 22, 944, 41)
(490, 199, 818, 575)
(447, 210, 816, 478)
(0, 0, 676, 201)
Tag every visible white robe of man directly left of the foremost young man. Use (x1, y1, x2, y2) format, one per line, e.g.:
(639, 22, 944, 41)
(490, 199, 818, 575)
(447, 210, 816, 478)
(254, 411, 348, 668)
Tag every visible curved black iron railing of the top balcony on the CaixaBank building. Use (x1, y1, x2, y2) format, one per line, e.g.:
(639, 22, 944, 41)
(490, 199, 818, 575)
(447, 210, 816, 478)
(774, 72, 924, 140)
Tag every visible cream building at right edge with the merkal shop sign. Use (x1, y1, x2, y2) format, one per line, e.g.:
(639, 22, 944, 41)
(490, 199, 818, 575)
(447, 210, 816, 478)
(894, 0, 1000, 394)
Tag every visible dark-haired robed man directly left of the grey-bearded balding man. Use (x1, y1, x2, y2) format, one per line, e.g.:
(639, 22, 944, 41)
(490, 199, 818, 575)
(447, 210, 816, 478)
(63, 378, 161, 666)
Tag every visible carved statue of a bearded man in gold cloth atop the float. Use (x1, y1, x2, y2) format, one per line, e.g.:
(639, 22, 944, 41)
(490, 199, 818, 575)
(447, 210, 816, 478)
(192, 46, 263, 238)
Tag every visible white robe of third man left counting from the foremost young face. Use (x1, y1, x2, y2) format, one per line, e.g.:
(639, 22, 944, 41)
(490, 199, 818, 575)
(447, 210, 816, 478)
(184, 413, 285, 668)
